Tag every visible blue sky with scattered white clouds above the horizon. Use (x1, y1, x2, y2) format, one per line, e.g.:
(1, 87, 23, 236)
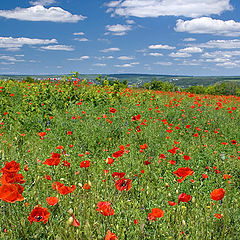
(0, 0, 240, 76)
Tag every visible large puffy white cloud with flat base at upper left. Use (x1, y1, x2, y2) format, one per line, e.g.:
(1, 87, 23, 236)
(0, 5, 86, 22)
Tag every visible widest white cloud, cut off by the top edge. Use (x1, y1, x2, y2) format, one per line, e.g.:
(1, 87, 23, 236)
(106, 0, 233, 18)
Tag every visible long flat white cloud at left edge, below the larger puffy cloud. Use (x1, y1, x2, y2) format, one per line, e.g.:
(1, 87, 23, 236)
(0, 37, 57, 51)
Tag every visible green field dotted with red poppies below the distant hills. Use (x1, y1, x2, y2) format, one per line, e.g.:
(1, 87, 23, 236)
(0, 79, 240, 240)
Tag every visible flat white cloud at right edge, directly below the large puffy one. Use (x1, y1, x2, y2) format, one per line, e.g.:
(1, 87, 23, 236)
(194, 39, 240, 49)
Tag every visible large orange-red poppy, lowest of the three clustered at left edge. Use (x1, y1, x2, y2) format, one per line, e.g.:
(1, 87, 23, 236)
(0, 183, 24, 203)
